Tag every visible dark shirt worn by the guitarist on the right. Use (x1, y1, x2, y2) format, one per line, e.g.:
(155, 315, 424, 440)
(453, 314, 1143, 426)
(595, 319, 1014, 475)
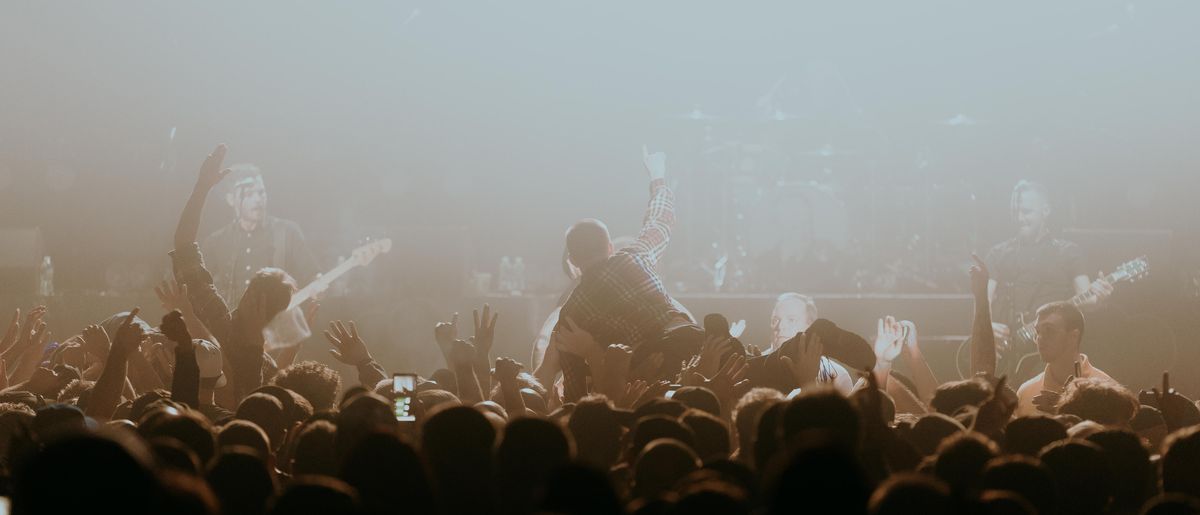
(985, 236, 1087, 324)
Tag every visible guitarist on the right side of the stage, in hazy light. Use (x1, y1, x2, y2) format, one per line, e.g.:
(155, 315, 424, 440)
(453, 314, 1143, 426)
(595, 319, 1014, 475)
(985, 180, 1112, 373)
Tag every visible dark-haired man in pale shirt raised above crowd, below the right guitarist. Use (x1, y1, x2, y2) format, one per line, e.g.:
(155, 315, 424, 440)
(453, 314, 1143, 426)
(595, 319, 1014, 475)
(1014, 303, 1112, 417)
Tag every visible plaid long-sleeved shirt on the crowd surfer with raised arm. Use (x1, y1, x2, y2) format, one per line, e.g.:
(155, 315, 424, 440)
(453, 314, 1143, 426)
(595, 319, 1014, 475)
(556, 179, 690, 401)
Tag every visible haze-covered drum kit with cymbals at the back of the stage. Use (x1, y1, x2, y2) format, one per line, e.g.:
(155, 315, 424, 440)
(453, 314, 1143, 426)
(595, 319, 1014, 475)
(667, 80, 982, 293)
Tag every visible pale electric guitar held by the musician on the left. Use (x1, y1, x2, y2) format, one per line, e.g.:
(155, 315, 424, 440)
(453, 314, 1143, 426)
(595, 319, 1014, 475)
(263, 238, 391, 351)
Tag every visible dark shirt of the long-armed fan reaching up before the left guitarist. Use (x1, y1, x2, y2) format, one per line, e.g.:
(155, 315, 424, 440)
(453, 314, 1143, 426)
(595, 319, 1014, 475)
(170, 244, 265, 399)
